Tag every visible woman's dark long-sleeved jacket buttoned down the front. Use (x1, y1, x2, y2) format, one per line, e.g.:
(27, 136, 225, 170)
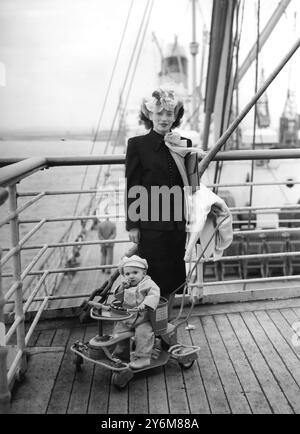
(125, 130, 192, 231)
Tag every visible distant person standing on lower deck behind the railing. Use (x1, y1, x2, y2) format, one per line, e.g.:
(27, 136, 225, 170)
(97, 213, 117, 274)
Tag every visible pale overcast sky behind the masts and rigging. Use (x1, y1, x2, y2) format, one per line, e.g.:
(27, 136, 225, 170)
(0, 0, 300, 133)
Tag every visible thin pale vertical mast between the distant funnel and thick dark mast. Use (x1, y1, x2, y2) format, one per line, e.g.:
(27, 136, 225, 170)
(190, 0, 199, 131)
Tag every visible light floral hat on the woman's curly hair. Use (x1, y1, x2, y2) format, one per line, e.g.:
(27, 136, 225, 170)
(141, 87, 183, 119)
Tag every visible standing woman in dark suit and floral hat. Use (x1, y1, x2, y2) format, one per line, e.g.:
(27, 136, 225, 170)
(125, 89, 192, 304)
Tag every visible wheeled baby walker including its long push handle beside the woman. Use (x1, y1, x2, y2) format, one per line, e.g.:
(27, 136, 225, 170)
(71, 216, 228, 389)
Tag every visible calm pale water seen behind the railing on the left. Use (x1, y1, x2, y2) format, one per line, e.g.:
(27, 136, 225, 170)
(0, 140, 123, 286)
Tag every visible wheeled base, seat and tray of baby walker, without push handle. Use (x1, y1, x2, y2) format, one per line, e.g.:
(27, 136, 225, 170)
(71, 286, 200, 389)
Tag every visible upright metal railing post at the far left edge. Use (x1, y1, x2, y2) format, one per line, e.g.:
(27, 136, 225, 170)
(9, 184, 27, 373)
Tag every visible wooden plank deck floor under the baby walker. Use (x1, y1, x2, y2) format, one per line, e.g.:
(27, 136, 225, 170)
(7, 299, 300, 414)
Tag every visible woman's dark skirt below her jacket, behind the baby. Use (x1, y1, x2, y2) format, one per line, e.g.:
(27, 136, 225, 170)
(138, 229, 186, 298)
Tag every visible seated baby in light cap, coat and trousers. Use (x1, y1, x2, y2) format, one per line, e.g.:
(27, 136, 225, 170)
(114, 255, 160, 369)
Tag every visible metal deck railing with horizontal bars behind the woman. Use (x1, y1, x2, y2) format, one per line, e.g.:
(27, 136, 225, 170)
(0, 149, 300, 408)
